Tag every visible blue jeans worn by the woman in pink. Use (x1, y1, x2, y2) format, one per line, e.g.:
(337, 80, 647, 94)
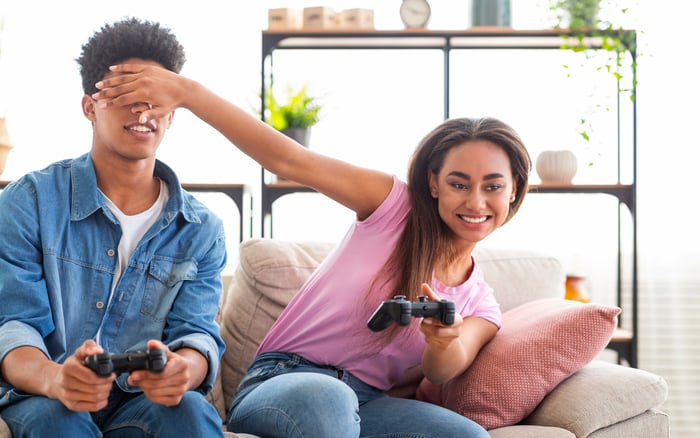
(227, 353, 489, 438)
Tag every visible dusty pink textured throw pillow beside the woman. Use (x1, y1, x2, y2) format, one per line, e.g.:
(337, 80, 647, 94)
(416, 298, 621, 429)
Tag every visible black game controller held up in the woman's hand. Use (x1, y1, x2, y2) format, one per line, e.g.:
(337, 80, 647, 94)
(367, 295, 455, 332)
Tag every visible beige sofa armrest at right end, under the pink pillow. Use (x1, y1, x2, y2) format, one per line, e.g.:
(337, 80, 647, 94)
(524, 360, 668, 437)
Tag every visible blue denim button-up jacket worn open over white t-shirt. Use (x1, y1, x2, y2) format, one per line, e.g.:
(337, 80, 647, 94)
(0, 154, 226, 406)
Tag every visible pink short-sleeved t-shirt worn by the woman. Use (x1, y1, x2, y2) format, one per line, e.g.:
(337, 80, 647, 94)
(258, 177, 501, 390)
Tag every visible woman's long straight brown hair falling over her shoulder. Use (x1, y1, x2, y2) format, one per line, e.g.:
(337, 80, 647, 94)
(370, 118, 532, 343)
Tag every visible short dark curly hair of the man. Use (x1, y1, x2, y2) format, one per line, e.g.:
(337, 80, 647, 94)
(76, 17, 185, 94)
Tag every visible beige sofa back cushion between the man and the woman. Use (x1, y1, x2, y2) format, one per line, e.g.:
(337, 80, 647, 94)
(217, 239, 332, 416)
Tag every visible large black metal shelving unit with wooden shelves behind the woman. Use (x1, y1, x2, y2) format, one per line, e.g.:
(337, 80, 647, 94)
(260, 28, 638, 367)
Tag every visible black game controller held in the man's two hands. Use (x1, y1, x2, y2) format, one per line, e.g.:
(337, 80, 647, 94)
(85, 348, 168, 377)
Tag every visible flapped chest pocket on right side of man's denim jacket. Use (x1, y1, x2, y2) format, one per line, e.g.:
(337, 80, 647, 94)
(141, 256, 197, 321)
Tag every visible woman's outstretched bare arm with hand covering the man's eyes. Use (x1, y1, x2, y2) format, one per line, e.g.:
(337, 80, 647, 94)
(92, 64, 392, 219)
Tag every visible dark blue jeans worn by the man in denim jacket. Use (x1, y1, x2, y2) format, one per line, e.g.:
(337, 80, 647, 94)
(0, 386, 223, 438)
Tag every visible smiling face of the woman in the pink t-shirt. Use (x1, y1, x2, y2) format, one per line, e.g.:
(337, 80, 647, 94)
(429, 140, 516, 249)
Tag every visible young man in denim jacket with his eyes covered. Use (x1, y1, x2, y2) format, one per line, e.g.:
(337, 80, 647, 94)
(0, 18, 226, 437)
